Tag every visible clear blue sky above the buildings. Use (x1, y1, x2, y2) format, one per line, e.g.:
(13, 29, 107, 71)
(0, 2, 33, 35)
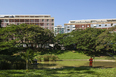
(0, 0, 116, 26)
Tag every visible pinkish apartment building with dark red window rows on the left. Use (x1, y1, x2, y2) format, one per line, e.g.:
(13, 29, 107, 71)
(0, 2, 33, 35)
(0, 15, 54, 30)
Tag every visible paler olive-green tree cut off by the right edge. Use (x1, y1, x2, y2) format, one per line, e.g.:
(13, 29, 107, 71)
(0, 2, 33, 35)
(96, 26, 116, 51)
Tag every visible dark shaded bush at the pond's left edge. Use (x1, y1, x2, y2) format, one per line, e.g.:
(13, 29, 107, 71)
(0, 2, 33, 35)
(0, 55, 26, 70)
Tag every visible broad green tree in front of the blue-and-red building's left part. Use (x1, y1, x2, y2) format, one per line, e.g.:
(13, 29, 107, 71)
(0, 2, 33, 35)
(56, 28, 105, 55)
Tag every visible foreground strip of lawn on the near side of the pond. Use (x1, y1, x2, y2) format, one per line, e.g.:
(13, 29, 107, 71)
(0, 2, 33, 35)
(0, 66, 116, 77)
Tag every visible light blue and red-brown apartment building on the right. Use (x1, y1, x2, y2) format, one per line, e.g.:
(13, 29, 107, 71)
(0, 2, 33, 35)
(64, 19, 116, 33)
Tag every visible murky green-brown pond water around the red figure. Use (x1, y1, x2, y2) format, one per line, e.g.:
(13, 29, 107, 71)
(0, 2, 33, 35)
(31, 61, 116, 68)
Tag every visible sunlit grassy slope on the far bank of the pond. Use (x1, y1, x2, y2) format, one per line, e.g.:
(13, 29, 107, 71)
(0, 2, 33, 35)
(36, 50, 114, 60)
